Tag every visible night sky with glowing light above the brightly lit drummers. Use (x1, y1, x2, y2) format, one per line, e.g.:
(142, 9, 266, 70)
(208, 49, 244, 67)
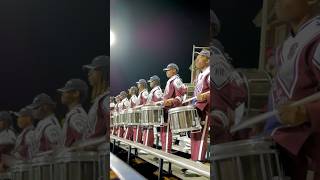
(110, 0, 210, 95)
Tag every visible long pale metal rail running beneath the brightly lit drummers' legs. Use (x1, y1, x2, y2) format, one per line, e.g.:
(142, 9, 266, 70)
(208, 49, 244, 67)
(110, 135, 210, 177)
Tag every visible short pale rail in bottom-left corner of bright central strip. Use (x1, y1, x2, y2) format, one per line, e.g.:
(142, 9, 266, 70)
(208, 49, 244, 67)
(110, 153, 146, 180)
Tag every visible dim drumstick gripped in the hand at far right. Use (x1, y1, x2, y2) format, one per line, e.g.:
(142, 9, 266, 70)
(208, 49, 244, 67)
(230, 92, 320, 133)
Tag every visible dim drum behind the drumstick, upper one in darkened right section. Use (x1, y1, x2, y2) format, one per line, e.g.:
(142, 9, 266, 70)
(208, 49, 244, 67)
(238, 69, 271, 117)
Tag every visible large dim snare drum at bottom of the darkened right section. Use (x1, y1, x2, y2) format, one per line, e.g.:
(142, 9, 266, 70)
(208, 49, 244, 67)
(212, 139, 283, 180)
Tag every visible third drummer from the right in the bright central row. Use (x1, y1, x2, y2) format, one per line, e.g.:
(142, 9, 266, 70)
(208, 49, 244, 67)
(143, 75, 163, 147)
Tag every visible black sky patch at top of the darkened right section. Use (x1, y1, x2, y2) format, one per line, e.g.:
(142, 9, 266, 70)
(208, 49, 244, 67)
(211, 0, 262, 68)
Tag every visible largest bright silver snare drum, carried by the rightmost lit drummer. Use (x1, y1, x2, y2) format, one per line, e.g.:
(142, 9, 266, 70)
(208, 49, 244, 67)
(168, 106, 201, 133)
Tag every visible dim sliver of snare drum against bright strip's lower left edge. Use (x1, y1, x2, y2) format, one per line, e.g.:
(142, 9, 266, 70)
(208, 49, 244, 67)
(98, 143, 110, 180)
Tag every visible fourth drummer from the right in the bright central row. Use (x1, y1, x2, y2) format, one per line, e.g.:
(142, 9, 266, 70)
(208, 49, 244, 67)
(133, 79, 148, 143)
